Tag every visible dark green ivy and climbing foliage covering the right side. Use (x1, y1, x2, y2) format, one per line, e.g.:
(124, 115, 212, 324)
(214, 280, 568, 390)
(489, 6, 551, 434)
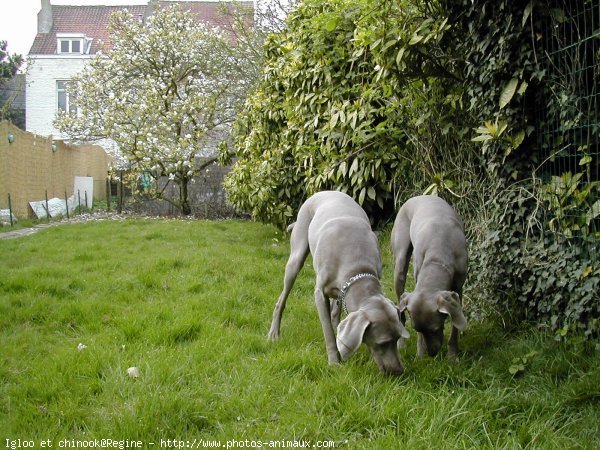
(450, 1, 600, 338)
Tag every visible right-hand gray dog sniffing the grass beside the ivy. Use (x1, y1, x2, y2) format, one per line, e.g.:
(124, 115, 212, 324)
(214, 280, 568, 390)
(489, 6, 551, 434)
(392, 195, 468, 357)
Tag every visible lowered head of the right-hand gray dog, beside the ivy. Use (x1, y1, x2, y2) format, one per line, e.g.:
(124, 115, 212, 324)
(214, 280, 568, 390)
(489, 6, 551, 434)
(398, 291, 467, 356)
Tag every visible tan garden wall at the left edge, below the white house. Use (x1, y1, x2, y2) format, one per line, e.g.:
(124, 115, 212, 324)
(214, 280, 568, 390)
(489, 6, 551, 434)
(0, 122, 112, 218)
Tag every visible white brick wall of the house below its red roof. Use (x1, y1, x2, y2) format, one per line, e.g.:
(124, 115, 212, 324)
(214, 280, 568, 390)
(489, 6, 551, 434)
(26, 55, 89, 139)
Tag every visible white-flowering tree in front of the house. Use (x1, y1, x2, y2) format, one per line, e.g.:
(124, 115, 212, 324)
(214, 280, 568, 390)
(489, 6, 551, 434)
(55, 6, 246, 214)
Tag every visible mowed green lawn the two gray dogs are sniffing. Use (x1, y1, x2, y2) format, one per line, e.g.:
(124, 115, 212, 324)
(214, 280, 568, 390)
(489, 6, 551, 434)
(0, 219, 600, 449)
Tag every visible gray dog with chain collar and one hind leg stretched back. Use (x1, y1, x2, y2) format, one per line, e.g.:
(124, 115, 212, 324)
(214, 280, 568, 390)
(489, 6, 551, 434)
(268, 191, 408, 375)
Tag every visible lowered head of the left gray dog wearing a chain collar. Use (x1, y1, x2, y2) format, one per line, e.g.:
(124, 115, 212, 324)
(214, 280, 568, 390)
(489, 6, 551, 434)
(337, 296, 409, 375)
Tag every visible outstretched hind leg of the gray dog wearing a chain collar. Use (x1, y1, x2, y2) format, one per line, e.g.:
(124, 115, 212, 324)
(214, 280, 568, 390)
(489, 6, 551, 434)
(267, 224, 309, 341)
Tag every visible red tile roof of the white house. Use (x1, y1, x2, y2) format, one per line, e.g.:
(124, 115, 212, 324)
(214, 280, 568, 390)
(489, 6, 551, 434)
(29, 1, 253, 55)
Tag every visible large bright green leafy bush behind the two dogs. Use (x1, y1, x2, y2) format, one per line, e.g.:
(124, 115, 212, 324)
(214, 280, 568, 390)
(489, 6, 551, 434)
(226, 0, 454, 226)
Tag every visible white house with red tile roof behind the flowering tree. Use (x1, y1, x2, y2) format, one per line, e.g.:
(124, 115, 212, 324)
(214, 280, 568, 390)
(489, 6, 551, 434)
(26, 0, 252, 139)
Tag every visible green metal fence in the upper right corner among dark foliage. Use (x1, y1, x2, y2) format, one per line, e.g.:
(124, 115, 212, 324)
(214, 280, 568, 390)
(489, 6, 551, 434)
(534, 0, 600, 250)
